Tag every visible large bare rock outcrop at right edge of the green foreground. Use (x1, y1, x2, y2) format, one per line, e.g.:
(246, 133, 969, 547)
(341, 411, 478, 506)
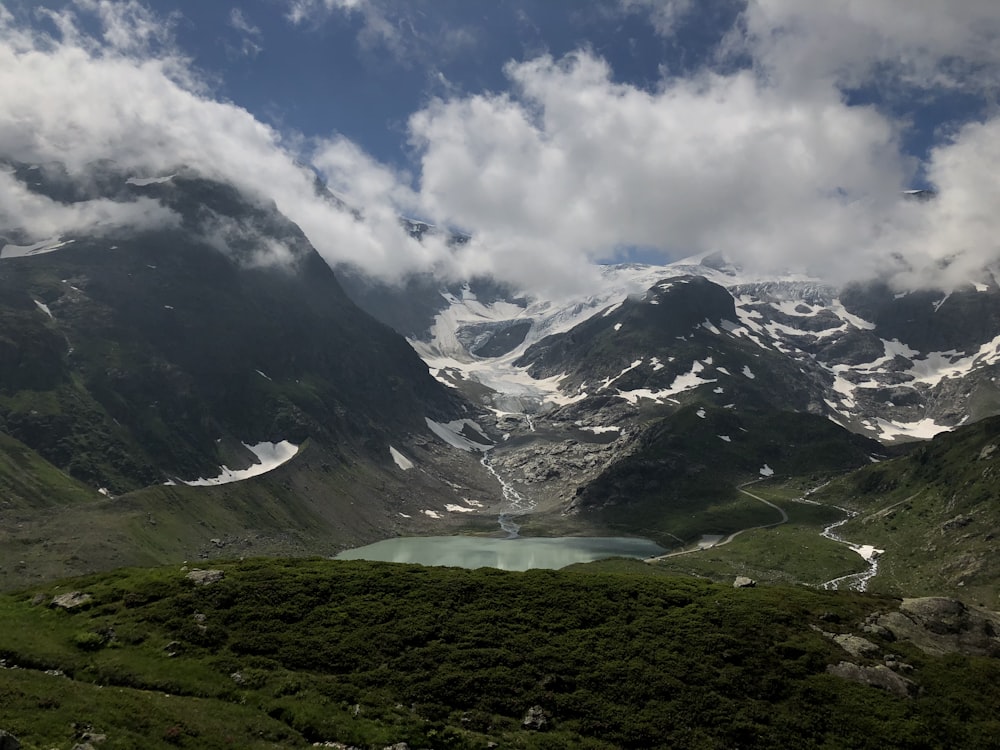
(876, 596, 1000, 656)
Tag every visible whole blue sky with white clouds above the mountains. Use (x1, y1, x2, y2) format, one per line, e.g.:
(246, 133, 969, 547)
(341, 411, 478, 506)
(0, 0, 1000, 294)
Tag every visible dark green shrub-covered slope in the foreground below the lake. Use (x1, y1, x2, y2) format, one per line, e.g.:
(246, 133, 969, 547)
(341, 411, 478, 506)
(0, 560, 1000, 750)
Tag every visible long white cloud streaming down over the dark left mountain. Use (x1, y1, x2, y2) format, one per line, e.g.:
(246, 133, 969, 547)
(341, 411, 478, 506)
(0, 0, 446, 279)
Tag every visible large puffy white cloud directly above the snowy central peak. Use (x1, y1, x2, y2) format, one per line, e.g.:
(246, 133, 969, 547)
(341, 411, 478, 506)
(411, 53, 909, 290)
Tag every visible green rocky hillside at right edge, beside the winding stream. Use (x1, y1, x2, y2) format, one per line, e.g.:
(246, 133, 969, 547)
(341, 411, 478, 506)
(815, 417, 1000, 607)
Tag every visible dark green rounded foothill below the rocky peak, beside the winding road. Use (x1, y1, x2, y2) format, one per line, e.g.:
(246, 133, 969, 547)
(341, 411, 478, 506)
(576, 403, 877, 547)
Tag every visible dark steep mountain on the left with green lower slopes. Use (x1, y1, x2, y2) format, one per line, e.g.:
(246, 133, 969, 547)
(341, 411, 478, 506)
(0, 163, 504, 588)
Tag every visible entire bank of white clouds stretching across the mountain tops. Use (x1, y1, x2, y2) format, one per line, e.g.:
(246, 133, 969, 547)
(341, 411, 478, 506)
(0, 0, 1000, 292)
